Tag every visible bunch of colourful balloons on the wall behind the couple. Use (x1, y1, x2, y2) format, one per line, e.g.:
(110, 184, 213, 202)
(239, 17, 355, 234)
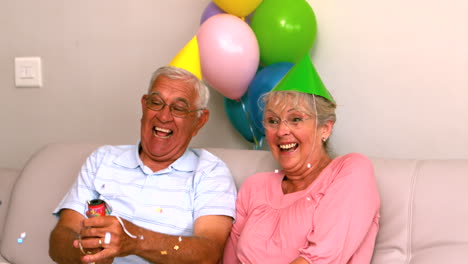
(176, 0, 317, 149)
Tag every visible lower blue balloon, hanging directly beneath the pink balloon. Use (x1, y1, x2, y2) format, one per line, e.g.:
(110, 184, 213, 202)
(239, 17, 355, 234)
(224, 93, 263, 145)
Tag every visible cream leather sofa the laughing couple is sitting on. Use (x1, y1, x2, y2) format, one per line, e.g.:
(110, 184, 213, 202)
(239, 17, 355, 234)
(0, 143, 468, 264)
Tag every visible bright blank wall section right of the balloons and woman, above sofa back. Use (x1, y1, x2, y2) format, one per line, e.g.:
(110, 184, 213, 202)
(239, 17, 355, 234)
(310, 0, 468, 158)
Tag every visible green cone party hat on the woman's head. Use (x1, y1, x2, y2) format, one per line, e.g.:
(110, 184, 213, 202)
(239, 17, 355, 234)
(272, 54, 334, 102)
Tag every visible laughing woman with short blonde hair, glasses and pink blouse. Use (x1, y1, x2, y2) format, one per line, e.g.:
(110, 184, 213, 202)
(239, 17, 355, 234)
(223, 75, 380, 264)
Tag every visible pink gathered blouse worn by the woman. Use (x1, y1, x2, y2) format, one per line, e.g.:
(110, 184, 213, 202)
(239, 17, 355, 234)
(223, 153, 380, 264)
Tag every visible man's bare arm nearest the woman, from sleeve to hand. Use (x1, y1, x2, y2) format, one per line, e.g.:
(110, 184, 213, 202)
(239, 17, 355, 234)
(81, 213, 232, 264)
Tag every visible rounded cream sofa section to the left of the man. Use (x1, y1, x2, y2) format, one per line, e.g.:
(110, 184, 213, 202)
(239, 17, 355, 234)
(0, 143, 99, 264)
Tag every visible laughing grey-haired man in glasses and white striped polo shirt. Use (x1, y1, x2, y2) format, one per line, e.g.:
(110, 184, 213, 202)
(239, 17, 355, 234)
(49, 66, 236, 264)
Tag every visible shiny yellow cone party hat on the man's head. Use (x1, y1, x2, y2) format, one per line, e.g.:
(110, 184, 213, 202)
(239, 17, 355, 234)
(169, 35, 202, 80)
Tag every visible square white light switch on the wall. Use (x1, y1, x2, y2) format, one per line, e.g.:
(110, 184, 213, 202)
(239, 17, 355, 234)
(15, 57, 42, 87)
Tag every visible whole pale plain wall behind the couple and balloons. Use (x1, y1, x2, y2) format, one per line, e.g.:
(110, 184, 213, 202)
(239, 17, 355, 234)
(0, 0, 468, 168)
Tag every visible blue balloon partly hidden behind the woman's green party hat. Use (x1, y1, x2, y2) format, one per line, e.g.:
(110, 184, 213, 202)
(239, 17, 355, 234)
(247, 62, 294, 135)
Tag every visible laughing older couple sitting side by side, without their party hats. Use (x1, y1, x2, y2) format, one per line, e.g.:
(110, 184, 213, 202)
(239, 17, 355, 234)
(49, 62, 380, 264)
